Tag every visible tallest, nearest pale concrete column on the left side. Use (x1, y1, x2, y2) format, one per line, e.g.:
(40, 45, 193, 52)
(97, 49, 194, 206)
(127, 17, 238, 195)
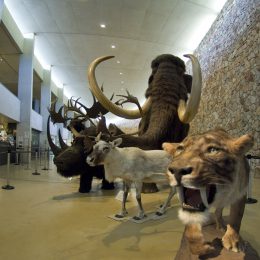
(16, 37, 34, 161)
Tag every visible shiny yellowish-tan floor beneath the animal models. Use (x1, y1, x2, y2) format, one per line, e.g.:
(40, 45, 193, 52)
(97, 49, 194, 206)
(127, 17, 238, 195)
(0, 157, 260, 260)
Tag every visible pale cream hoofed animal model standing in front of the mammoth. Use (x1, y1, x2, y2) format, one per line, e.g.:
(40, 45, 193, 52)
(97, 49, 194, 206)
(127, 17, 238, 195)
(87, 138, 175, 220)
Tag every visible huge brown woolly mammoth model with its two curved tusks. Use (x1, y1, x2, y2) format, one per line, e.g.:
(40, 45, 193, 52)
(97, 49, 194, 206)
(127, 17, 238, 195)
(88, 54, 201, 192)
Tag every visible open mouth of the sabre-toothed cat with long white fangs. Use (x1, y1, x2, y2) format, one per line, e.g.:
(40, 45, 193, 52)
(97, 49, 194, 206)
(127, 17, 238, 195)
(177, 185, 217, 212)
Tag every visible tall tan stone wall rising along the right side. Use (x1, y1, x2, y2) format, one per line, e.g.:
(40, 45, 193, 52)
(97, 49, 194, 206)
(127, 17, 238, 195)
(188, 0, 260, 155)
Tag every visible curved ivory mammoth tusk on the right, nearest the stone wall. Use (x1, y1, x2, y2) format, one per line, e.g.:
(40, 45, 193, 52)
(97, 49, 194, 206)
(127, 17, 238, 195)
(178, 54, 202, 124)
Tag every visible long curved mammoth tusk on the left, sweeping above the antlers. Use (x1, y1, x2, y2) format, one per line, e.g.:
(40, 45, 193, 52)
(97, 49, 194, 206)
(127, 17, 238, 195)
(88, 56, 151, 119)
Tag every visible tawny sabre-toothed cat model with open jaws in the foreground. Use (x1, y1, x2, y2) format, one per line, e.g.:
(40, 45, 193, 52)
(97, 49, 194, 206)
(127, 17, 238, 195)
(163, 130, 253, 254)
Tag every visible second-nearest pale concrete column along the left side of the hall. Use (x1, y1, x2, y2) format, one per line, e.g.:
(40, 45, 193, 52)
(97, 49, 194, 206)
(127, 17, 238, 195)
(40, 70, 51, 148)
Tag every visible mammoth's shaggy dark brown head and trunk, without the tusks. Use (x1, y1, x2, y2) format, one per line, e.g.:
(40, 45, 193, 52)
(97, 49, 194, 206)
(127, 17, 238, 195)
(116, 54, 191, 150)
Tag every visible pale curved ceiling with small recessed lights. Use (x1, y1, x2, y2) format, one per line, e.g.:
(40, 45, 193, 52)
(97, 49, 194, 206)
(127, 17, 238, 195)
(5, 0, 225, 123)
